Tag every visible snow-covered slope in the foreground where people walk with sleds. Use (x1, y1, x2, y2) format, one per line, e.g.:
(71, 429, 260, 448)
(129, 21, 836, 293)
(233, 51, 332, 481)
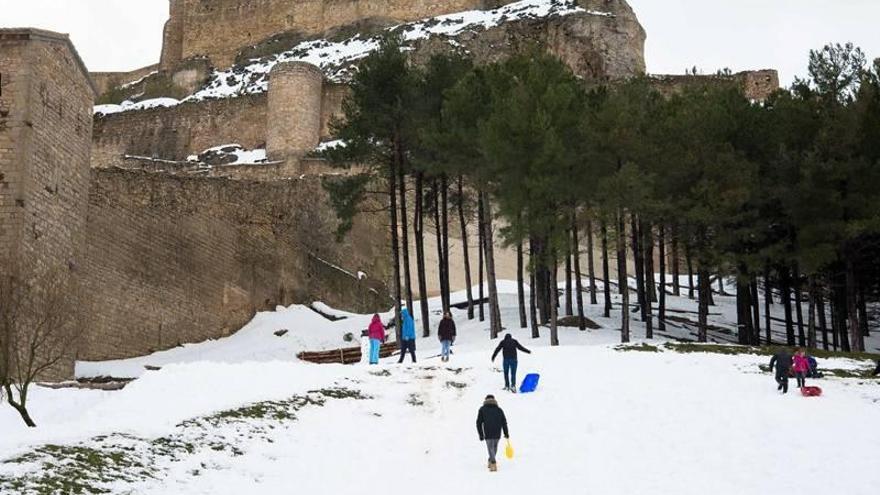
(0, 282, 880, 495)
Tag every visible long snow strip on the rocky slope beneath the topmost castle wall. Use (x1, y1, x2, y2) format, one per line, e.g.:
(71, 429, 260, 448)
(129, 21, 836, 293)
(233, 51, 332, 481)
(95, 0, 600, 115)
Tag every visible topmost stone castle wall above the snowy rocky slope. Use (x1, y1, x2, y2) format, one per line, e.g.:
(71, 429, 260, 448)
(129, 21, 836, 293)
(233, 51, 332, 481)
(162, 0, 510, 69)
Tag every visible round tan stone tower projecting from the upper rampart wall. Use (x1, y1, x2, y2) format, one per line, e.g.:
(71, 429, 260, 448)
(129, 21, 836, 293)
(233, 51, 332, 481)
(266, 62, 324, 161)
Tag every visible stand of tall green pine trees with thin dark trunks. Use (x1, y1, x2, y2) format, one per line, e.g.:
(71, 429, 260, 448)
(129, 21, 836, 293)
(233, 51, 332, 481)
(323, 38, 880, 352)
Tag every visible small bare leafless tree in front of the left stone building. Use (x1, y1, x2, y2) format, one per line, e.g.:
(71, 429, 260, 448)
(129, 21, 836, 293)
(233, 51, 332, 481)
(0, 270, 82, 427)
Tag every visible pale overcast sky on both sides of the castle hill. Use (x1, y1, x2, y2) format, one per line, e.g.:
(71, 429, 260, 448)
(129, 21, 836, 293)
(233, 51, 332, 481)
(0, 0, 880, 84)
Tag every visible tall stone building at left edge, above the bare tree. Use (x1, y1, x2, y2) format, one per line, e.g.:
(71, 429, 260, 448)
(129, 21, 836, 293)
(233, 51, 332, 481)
(0, 29, 95, 376)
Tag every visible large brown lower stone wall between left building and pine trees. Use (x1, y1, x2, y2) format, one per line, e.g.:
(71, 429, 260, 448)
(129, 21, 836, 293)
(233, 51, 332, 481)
(79, 169, 390, 360)
